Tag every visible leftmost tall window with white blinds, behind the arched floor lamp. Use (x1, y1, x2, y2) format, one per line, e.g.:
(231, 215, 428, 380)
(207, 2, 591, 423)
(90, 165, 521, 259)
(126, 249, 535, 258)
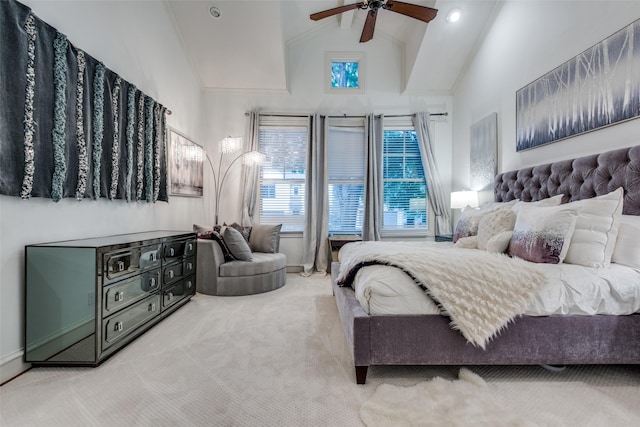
(258, 116, 309, 232)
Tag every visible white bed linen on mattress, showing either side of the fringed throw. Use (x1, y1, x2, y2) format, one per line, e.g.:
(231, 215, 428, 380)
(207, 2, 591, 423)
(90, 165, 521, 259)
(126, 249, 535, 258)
(353, 243, 640, 316)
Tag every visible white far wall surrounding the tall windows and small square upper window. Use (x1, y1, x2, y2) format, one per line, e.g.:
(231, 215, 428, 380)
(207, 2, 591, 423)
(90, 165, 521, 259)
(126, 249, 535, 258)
(204, 24, 452, 266)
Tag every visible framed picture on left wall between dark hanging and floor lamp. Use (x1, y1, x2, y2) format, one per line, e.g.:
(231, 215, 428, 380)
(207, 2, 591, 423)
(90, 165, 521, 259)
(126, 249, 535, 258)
(169, 129, 205, 197)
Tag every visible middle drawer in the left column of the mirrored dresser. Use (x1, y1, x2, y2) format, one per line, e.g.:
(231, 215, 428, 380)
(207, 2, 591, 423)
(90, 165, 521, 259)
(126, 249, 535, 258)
(102, 269, 160, 317)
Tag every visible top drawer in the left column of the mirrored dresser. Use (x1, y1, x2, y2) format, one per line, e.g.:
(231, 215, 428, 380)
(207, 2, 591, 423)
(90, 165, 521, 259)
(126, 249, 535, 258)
(104, 245, 160, 281)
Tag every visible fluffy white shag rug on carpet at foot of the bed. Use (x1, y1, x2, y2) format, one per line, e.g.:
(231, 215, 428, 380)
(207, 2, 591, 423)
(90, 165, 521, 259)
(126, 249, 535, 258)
(360, 368, 640, 427)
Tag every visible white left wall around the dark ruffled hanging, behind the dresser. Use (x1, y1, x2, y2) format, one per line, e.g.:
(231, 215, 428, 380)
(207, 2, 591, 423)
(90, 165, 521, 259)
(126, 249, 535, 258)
(0, 0, 204, 382)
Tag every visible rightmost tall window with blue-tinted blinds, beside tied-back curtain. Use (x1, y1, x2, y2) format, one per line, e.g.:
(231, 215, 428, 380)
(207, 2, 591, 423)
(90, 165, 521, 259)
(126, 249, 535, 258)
(382, 125, 428, 234)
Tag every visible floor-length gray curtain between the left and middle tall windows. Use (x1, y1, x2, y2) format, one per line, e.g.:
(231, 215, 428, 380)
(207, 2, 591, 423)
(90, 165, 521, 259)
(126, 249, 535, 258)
(301, 114, 329, 276)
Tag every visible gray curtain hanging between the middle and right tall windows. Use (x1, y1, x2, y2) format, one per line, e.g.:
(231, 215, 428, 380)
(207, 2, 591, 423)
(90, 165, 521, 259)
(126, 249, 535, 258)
(362, 114, 384, 240)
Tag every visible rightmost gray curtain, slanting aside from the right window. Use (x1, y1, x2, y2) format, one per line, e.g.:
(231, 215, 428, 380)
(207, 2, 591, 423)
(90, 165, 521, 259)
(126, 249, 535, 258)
(413, 112, 451, 234)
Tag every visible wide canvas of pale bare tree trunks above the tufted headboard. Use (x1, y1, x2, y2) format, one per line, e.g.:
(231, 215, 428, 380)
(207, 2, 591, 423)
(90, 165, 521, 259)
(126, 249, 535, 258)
(516, 20, 640, 151)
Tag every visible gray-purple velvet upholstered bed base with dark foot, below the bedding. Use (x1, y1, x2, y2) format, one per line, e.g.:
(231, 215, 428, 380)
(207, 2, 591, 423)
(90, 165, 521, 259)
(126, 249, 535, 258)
(331, 263, 640, 384)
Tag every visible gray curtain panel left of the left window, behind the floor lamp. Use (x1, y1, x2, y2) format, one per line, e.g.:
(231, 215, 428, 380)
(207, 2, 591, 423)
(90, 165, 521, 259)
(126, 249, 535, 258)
(240, 111, 261, 227)
